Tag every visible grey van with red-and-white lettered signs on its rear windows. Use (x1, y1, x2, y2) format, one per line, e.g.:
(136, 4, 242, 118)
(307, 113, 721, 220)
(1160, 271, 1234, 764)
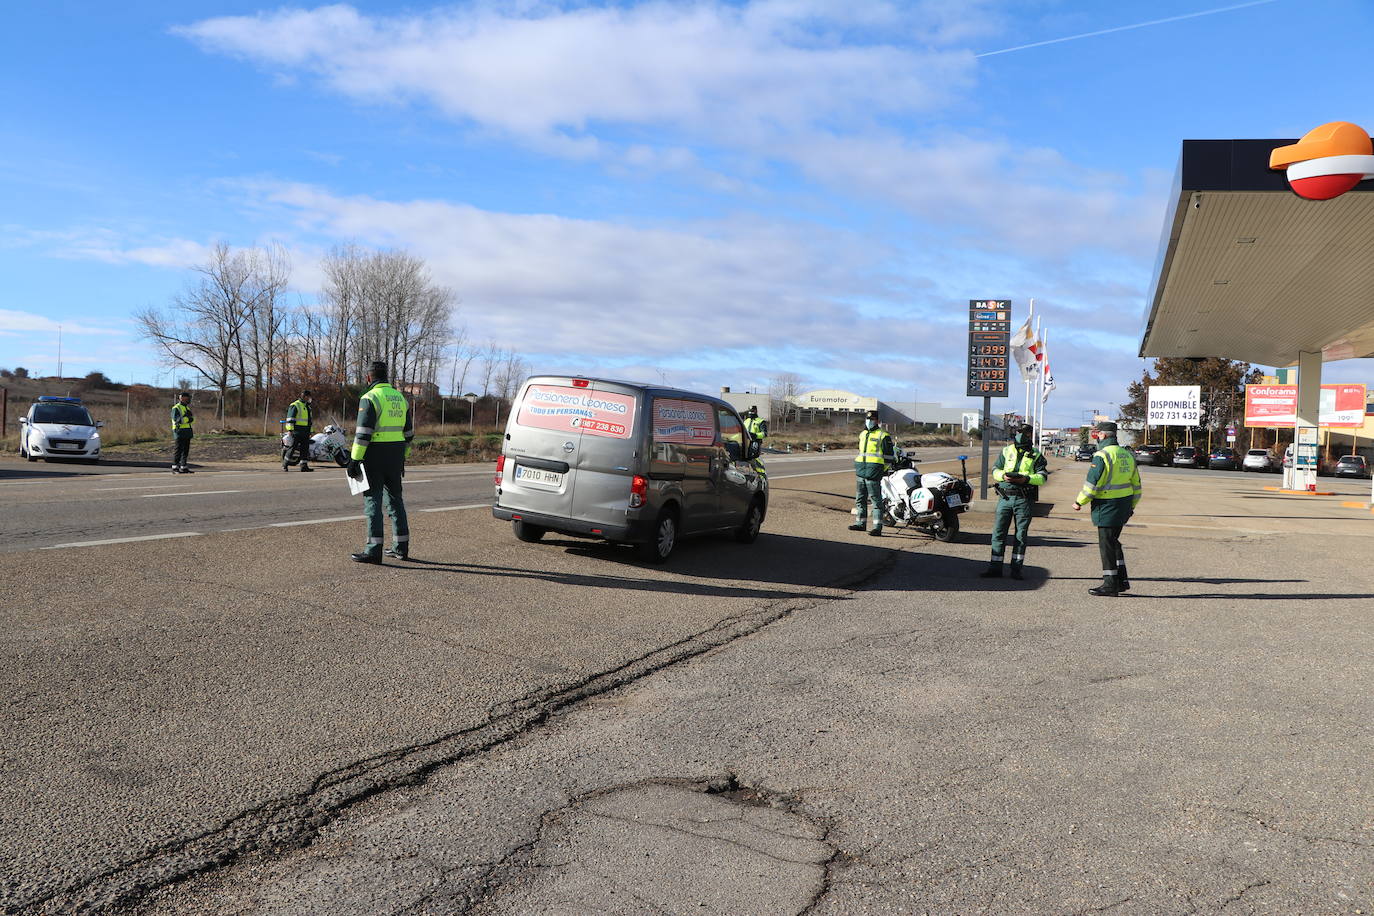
(492, 375, 768, 563)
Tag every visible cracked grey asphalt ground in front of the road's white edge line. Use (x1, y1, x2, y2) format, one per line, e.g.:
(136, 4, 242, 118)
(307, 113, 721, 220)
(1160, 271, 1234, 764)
(0, 463, 1374, 915)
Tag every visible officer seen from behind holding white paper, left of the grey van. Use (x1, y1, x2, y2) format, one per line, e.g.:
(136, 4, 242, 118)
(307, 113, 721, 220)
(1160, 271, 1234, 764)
(348, 360, 415, 563)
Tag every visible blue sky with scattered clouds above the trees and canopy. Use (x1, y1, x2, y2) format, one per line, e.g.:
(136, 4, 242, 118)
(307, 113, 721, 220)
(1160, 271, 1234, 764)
(0, 0, 1374, 424)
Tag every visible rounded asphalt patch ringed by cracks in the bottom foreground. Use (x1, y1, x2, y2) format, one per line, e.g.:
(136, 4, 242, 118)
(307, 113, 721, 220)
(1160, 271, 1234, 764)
(466, 776, 838, 916)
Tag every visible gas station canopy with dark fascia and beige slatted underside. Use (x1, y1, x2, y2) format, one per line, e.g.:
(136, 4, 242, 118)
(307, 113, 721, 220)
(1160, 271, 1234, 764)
(1140, 137, 1374, 367)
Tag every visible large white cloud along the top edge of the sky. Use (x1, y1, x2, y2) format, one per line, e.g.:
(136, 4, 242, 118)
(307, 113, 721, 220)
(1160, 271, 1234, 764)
(174, 1, 984, 140)
